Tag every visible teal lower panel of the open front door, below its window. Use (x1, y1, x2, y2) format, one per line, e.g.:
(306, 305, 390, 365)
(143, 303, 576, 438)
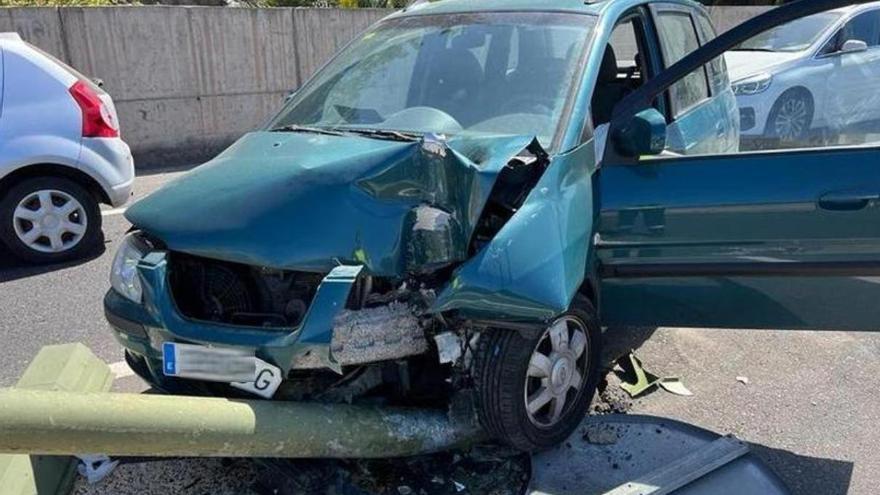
(597, 148, 880, 329)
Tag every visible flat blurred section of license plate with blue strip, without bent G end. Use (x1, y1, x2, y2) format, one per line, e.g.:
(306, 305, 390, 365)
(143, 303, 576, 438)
(162, 342, 257, 383)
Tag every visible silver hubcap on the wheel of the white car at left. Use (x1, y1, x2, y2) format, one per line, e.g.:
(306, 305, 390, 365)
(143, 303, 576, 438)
(12, 190, 88, 253)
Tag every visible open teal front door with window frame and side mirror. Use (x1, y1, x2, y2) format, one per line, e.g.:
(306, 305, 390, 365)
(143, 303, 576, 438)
(595, 0, 880, 330)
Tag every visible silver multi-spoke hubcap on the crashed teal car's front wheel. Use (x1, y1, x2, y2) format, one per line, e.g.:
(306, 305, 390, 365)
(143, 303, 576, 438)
(524, 316, 590, 427)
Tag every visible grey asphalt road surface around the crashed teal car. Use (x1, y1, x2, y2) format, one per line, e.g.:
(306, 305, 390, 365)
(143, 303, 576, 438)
(0, 168, 880, 494)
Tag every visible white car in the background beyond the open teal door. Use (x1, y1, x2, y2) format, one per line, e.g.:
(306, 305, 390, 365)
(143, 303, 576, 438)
(725, 2, 880, 149)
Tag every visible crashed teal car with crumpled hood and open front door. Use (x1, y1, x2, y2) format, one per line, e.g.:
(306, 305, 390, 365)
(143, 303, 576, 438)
(104, 0, 880, 450)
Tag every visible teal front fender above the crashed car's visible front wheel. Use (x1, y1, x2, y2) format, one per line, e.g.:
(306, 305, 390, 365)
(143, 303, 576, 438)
(435, 141, 595, 321)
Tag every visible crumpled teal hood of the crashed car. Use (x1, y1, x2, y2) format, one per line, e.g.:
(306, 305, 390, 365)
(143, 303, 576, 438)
(125, 132, 543, 276)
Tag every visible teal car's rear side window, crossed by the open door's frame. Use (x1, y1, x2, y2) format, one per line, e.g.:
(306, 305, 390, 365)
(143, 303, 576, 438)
(657, 11, 709, 117)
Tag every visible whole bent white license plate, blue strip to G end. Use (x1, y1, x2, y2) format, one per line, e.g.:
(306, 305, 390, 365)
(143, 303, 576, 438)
(162, 342, 283, 399)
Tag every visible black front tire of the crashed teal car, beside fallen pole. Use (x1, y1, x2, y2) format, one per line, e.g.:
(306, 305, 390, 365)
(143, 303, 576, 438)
(473, 297, 602, 452)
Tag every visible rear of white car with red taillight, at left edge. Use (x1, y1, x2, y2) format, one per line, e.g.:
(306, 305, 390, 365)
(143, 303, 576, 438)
(0, 33, 134, 263)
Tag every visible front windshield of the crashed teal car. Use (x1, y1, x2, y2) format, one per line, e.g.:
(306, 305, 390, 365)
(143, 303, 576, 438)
(270, 13, 595, 146)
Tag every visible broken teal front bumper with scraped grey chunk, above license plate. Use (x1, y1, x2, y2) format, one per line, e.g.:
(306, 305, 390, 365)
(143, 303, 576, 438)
(104, 251, 428, 388)
